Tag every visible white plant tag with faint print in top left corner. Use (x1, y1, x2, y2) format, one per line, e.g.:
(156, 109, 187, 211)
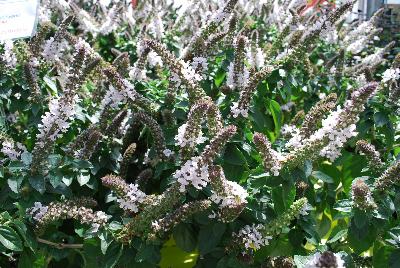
(0, 0, 39, 41)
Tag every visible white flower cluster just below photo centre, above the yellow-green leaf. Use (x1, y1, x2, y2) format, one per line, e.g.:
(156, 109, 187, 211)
(174, 156, 209, 192)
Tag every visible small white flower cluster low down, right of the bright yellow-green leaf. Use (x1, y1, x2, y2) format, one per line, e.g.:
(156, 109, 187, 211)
(233, 224, 272, 250)
